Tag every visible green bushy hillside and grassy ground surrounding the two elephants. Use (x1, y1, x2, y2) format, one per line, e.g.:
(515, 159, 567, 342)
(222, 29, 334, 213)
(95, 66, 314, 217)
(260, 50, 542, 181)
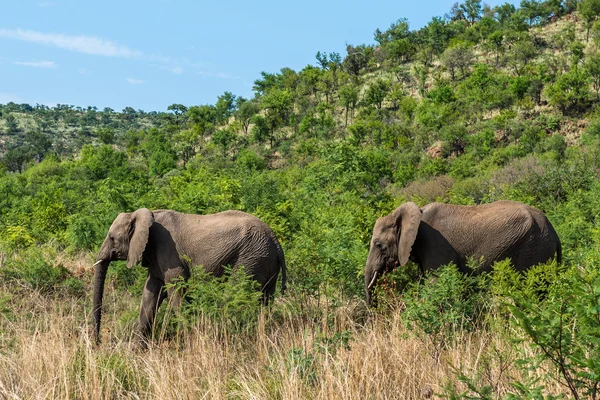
(0, 0, 600, 399)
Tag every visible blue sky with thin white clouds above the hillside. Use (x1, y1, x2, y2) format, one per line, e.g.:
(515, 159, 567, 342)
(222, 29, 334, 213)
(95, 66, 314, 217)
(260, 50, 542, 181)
(0, 0, 518, 111)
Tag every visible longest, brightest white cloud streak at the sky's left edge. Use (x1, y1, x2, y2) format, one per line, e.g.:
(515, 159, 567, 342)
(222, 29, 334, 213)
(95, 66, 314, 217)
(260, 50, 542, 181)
(0, 29, 145, 58)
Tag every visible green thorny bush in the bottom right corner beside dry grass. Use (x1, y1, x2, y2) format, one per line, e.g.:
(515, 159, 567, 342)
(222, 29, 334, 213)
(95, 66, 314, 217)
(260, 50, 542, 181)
(494, 259, 600, 398)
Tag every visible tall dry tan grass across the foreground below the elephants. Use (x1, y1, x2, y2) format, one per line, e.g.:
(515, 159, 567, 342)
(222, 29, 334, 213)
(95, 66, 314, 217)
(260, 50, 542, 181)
(0, 278, 561, 399)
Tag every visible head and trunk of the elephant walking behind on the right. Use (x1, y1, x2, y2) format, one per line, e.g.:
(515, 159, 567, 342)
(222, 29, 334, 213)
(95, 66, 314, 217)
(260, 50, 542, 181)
(365, 203, 421, 305)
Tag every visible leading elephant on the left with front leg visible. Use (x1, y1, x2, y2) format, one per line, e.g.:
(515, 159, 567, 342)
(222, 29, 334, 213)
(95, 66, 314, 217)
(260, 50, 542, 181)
(93, 208, 286, 342)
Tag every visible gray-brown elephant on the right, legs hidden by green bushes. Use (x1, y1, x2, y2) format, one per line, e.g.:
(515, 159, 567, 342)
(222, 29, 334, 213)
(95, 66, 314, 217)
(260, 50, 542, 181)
(365, 201, 561, 304)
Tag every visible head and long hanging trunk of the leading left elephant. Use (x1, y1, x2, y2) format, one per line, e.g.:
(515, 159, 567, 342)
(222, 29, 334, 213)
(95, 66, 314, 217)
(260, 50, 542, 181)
(93, 208, 154, 342)
